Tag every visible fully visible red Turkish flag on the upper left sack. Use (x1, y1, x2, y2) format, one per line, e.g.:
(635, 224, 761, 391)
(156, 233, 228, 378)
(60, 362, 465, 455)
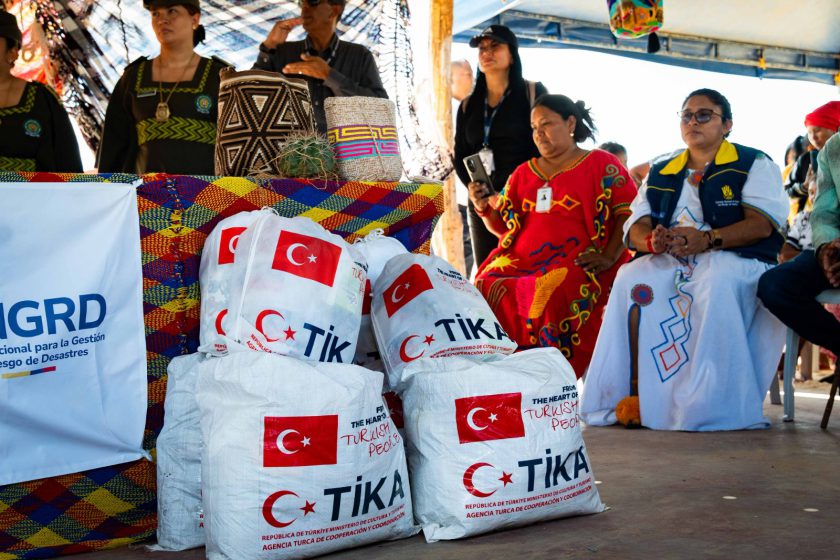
(271, 231, 341, 288)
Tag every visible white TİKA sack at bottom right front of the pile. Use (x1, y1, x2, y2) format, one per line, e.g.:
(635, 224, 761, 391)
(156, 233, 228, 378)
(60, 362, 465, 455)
(402, 348, 604, 542)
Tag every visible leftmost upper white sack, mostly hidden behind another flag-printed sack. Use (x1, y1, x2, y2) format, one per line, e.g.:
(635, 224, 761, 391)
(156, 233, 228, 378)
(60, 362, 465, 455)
(198, 210, 271, 356)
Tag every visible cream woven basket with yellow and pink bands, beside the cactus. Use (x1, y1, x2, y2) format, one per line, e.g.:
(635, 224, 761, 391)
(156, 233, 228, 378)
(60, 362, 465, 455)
(324, 97, 403, 181)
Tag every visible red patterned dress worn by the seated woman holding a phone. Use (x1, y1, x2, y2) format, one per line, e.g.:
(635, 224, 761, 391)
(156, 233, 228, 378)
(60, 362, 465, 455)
(476, 150, 636, 377)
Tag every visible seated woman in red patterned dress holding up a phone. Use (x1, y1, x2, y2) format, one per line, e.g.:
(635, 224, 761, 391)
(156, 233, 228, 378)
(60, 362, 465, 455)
(470, 95, 636, 377)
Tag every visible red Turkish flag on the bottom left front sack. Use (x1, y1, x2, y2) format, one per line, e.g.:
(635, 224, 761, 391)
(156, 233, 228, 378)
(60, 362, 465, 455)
(263, 414, 338, 467)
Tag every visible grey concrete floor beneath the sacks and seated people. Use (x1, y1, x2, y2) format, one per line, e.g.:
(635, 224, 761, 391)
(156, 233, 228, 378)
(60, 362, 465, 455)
(75, 383, 840, 560)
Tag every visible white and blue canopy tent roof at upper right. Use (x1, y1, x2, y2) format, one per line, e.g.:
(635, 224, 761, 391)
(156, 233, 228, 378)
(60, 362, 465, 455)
(453, 0, 840, 84)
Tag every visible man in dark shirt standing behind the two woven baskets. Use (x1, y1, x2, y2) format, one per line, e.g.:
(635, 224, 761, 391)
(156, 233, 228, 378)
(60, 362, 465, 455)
(254, 0, 388, 133)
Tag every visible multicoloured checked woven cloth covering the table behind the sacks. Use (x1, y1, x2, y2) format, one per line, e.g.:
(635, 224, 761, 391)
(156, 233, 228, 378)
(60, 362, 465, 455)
(0, 173, 443, 560)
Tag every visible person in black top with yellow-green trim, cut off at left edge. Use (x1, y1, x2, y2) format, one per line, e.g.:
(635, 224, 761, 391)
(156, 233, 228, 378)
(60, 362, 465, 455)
(0, 10, 82, 173)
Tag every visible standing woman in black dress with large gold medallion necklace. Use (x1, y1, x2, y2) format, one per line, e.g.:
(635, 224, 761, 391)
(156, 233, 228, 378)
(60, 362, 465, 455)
(97, 0, 225, 175)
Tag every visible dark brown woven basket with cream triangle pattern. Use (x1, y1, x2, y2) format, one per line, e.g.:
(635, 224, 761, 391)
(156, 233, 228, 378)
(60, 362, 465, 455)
(215, 68, 315, 177)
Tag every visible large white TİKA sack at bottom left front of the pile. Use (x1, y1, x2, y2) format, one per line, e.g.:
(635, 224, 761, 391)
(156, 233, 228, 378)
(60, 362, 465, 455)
(197, 352, 419, 560)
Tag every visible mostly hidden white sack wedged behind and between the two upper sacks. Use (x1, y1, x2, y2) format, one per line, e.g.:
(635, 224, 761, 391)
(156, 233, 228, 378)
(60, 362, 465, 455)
(353, 229, 408, 371)
